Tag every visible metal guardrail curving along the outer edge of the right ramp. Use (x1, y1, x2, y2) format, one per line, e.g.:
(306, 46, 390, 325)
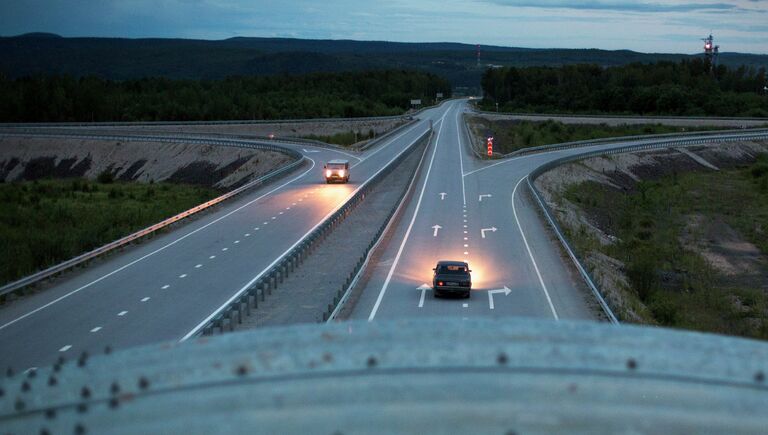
(526, 131, 768, 323)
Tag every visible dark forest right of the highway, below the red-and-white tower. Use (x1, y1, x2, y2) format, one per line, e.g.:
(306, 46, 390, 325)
(481, 58, 768, 117)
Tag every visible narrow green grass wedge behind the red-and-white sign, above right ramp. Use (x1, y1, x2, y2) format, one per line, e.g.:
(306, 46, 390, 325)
(470, 118, 728, 154)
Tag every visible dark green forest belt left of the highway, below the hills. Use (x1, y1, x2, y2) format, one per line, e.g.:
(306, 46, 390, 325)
(0, 70, 451, 122)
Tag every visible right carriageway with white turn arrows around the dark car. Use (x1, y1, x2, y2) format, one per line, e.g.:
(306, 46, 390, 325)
(350, 102, 764, 321)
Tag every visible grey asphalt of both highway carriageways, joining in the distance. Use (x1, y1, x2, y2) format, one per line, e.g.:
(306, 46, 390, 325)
(0, 100, 760, 370)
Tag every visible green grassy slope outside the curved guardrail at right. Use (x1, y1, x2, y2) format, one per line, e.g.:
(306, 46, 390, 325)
(564, 155, 768, 339)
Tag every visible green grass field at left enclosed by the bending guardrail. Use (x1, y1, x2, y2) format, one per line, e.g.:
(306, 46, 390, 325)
(0, 179, 220, 283)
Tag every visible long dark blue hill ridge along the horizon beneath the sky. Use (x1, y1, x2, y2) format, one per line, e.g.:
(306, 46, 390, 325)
(0, 33, 768, 89)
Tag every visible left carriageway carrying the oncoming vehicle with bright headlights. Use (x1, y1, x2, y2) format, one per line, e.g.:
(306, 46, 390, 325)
(0, 102, 456, 370)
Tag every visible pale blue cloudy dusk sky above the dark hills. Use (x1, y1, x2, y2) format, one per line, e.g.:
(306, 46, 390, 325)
(0, 0, 768, 54)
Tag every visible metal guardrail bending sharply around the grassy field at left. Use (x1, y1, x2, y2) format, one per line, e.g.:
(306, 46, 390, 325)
(0, 133, 305, 299)
